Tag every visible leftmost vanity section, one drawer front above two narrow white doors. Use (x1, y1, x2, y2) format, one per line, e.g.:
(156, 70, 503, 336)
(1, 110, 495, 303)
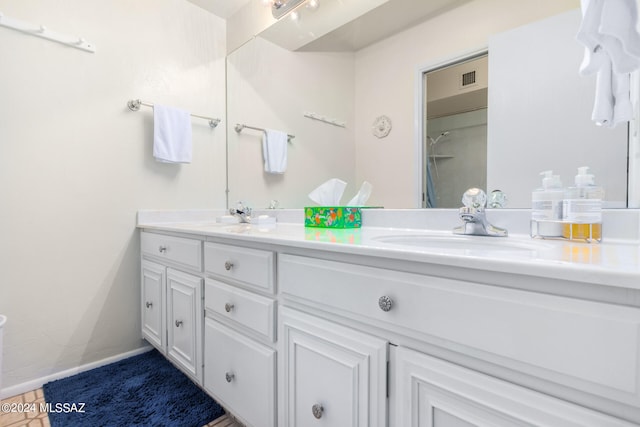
(140, 232, 203, 384)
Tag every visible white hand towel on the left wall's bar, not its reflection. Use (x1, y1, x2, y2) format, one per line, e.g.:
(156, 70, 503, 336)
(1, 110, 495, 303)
(153, 104, 192, 163)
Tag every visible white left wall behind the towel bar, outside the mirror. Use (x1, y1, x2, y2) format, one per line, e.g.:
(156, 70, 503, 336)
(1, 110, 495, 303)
(0, 0, 225, 398)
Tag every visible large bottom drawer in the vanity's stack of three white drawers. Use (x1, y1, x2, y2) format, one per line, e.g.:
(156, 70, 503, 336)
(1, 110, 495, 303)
(204, 318, 276, 427)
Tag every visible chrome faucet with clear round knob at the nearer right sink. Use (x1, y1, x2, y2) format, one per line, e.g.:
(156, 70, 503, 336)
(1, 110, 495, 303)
(453, 188, 507, 237)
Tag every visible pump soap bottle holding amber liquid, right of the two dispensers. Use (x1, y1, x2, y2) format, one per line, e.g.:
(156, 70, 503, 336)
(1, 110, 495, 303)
(562, 166, 604, 242)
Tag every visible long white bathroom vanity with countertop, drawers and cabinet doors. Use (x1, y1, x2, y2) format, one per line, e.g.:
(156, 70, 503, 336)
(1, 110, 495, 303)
(138, 212, 640, 427)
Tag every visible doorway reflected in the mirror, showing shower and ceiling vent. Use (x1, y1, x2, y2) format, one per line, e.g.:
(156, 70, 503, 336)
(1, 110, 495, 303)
(421, 52, 488, 208)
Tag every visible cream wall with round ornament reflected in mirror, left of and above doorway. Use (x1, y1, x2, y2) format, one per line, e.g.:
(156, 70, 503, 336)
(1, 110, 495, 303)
(355, 0, 580, 208)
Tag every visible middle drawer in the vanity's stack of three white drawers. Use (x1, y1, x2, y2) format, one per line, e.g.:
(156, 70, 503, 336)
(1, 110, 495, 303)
(204, 279, 275, 342)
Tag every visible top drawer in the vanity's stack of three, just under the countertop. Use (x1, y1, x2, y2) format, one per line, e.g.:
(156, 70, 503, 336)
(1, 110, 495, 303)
(204, 242, 274, 293)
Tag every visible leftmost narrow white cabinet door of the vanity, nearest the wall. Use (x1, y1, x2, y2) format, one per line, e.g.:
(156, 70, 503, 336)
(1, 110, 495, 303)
(140, 261, 167, 353)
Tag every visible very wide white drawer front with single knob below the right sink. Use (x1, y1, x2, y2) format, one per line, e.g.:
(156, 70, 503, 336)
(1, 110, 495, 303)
(278, 255, 640, 407)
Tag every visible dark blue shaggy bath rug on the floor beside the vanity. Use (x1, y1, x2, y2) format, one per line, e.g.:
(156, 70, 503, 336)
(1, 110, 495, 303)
(43, 350, 224, 427)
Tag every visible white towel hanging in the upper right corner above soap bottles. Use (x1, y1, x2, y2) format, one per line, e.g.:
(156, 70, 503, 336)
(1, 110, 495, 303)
(576, 0, 640, 127)
